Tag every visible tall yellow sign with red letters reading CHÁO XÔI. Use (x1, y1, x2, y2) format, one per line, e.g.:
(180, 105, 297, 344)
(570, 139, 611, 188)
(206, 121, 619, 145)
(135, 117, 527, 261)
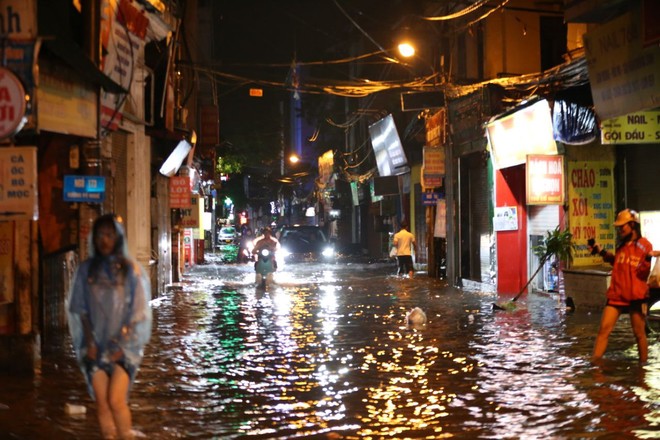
(568, 161, 615, 266)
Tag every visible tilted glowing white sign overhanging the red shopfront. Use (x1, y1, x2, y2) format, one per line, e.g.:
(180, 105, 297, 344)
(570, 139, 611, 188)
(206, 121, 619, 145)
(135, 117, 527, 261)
(486, 99, 557, 170)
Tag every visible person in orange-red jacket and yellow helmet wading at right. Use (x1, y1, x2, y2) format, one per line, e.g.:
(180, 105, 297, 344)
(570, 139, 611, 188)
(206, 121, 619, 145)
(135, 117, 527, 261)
(591, 209, 660, 363)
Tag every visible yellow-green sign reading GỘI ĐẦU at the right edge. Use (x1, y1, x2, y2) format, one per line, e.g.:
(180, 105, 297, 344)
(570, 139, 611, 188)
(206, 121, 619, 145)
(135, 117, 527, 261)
(600, 110, 660, 144)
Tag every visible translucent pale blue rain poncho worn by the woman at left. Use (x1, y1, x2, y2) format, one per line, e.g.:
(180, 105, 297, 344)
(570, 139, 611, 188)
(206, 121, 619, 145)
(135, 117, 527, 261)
(67, 220, 152, 398)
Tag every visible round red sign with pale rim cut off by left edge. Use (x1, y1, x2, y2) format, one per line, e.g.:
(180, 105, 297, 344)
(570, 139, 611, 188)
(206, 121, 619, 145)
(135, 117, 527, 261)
(0, 67, 26, 139)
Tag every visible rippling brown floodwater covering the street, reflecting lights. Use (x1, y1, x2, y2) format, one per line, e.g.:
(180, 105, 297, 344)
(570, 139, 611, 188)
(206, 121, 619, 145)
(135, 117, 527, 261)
(0, 261, 660, 439)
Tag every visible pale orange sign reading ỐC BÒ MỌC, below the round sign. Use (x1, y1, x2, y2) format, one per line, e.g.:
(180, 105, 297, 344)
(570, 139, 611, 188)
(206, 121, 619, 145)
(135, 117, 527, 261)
(0, 147, 39, 220)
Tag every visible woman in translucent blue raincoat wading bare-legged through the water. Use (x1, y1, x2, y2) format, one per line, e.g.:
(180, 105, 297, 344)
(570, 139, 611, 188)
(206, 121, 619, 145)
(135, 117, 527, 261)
(67, 214, 151, 439)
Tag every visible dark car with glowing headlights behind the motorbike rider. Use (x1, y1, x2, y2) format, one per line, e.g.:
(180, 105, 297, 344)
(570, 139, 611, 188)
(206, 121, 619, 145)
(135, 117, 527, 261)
(279, 225, 335, 262)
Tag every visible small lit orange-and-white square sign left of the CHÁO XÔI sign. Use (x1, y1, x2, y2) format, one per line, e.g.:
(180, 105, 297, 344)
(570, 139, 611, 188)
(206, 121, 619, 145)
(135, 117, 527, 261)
(525, 155, 564, 205)
